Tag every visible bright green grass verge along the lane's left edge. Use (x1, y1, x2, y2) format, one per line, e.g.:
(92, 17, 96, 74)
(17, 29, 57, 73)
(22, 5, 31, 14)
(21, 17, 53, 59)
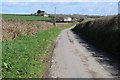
(2, 26, 68, 78)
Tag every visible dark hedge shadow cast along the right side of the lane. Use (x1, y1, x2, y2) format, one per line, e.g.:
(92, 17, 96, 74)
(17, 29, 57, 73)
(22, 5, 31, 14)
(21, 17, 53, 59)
(72, 31, 120, 77)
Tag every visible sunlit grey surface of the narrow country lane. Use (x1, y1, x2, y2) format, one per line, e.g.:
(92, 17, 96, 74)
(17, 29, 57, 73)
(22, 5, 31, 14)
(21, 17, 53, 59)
(50, 26, 118, 78)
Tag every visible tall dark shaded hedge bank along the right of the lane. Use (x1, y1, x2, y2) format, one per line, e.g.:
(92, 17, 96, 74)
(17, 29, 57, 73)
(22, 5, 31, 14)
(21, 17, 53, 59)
(73, 15, 120, 56)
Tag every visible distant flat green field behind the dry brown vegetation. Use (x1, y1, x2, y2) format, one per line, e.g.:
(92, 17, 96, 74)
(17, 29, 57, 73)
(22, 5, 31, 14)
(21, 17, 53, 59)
(1, 14, 52, 21)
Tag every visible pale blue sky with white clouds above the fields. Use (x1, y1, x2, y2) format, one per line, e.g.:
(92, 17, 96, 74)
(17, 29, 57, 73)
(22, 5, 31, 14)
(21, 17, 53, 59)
(0, 0, 118, 15)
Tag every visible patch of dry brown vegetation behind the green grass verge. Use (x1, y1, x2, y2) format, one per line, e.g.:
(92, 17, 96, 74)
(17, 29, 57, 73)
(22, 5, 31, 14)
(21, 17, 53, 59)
(2, 20, 54, 40)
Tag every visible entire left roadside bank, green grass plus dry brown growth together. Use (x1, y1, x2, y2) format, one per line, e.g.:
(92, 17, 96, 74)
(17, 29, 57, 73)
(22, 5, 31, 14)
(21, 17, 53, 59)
(2, 15, 71, 78)
